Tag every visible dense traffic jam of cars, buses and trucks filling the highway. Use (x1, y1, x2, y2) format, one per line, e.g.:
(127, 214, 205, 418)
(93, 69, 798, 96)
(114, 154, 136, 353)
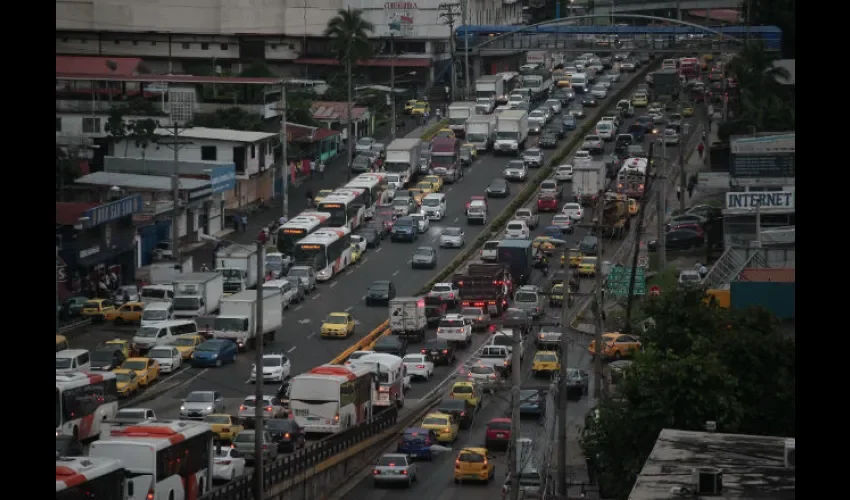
(56, 49, 704, 500)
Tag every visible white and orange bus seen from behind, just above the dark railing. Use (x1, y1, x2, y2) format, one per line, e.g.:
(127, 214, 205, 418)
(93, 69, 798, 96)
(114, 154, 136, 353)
(289, 365, 373, 434)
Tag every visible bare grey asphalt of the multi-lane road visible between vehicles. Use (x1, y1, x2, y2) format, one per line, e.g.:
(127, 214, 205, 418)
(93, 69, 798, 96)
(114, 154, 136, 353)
(73, 63, 684, 430)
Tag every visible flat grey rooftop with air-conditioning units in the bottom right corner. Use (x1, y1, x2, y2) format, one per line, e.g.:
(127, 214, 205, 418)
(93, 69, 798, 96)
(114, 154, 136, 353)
(629, 429, 796, 500)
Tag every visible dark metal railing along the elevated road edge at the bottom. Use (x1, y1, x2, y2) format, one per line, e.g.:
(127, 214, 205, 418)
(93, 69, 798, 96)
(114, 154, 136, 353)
(200, 407, 398, 500)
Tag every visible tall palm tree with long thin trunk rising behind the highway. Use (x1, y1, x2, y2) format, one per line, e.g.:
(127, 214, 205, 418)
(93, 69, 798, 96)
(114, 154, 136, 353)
(325, 7, 375, 166)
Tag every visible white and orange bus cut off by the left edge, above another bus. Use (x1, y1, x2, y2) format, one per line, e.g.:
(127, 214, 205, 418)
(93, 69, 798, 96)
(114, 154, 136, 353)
(56, 372, 118, 441)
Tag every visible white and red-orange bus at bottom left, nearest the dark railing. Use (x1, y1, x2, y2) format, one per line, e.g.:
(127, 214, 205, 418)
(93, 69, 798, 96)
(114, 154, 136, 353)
(89, 420, 215, 500)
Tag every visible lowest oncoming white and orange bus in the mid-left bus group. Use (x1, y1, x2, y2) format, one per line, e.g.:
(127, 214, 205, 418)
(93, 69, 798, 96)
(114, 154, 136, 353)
(293, 227, 351, 281)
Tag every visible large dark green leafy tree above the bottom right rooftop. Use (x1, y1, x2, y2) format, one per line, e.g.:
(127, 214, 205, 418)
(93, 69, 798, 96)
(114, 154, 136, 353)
(582, 291, 795, 498)
